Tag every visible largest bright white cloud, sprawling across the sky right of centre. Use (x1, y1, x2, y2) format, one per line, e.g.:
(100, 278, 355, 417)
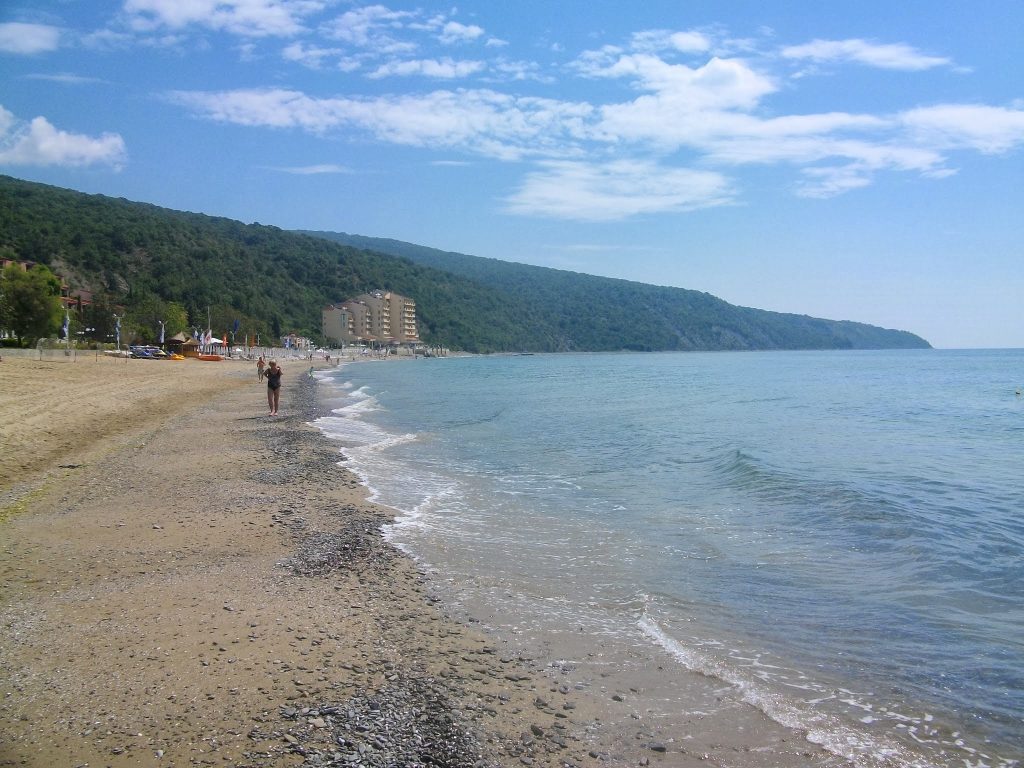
(577, 38, 958, 197)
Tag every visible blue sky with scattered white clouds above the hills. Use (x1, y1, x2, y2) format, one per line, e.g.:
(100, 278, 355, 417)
(0, 0, 1024, 347)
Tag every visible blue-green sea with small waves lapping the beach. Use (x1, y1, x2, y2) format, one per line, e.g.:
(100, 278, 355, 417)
(316, 349, 1024, 768)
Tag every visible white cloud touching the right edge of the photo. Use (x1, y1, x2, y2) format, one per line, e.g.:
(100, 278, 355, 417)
(899, 104, 1024, 155)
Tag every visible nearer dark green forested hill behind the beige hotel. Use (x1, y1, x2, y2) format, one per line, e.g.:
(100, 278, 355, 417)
(0, 176, 544, 351)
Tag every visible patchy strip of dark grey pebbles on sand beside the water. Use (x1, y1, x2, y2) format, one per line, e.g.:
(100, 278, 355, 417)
(239, 370, 618, 768)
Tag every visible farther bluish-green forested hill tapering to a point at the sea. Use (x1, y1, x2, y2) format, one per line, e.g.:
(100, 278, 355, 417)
(304, 231, 931, 350)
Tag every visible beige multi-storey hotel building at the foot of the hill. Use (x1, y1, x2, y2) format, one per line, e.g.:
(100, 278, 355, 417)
(323, 291, 420, 344)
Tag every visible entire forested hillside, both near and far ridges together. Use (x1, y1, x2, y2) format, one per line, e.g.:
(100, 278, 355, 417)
(0, 176, 928, 351)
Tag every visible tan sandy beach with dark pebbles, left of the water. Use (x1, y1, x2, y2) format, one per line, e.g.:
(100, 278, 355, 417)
(0, 356, 679, 766)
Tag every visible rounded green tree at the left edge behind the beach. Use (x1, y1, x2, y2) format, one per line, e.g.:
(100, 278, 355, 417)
(0, 264, 63, 346)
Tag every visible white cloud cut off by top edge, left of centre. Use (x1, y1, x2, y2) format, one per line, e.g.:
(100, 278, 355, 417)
(124, 0, 326, 37)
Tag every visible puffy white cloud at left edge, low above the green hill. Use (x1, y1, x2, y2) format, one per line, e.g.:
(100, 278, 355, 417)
(0, 106, 126, 168)
